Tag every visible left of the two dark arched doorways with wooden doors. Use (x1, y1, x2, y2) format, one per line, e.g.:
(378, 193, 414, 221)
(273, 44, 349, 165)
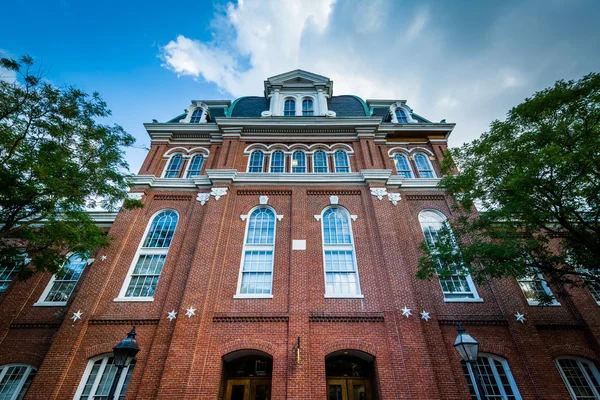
(223, 350, 273, 400)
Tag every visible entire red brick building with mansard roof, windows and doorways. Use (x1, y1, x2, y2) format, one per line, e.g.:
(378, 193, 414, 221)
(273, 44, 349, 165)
(0, 70, 600, 400)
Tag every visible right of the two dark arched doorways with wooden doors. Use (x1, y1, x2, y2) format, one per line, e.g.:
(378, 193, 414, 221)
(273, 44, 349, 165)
(325, 350, 374, 400)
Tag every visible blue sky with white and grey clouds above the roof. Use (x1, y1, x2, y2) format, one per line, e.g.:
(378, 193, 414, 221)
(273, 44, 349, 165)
(0, 0, 600, 172)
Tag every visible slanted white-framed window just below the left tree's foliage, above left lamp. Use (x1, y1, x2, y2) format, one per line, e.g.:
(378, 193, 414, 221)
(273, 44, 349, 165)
(35, 254, 88, 306)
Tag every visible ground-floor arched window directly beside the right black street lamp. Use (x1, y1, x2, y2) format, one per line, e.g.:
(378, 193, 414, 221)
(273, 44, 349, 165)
(462, 353, 521, 400)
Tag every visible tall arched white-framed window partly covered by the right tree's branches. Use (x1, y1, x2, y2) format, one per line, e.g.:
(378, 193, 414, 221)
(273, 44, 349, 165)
(419, 210, 479, 301)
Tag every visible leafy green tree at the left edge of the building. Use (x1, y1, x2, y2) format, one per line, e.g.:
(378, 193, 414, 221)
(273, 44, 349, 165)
(0, 56, 141, 278)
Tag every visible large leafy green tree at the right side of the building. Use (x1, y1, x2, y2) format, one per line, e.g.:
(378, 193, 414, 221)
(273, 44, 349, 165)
(418, 73, 600, 303)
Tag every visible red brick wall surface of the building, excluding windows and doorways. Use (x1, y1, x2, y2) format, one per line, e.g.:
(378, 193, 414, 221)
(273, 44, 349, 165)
(0, 70, 600, 400)
